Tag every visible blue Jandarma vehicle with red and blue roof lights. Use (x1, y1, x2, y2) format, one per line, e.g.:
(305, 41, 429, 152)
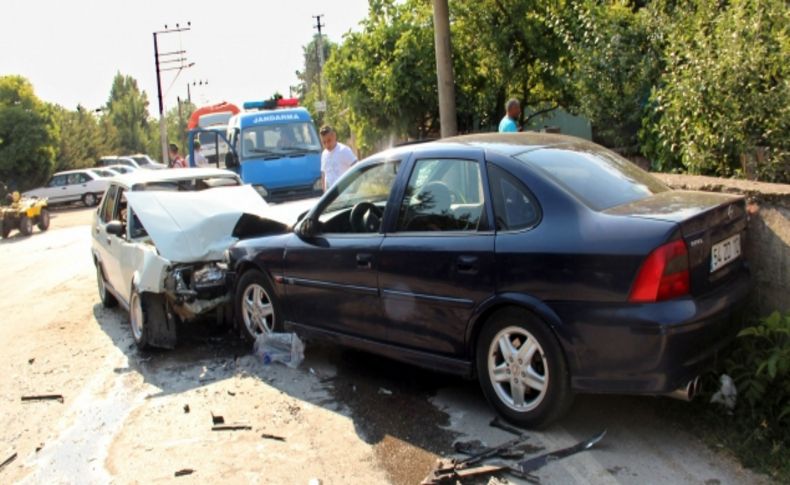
(188, 99, 323, 202)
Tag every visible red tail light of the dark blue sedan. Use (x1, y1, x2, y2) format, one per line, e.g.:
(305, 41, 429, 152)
(628, 240, 690, 302)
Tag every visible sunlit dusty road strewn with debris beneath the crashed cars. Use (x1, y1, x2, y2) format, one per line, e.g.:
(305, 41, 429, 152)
(0, 205, 767, 485)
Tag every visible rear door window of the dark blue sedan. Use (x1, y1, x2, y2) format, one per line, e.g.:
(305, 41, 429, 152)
(397, 159, 485, 231)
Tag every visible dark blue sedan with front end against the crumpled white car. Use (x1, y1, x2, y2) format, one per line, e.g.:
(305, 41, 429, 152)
(228, 133, 750, 427)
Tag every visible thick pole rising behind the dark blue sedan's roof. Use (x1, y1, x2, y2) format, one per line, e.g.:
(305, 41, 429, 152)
(433, 0, 458, 138)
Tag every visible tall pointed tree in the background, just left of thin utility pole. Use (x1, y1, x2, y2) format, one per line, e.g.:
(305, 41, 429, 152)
(106, 72, 159, 153)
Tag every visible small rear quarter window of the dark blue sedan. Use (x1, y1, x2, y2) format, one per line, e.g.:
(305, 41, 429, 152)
(488, 164, 540, 231)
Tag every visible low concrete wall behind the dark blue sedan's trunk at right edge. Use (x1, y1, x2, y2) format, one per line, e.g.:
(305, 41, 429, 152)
(655, 174, 790, 316)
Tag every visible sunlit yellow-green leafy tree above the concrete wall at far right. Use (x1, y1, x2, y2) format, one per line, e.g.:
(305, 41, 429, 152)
(641, 0, 790, 182)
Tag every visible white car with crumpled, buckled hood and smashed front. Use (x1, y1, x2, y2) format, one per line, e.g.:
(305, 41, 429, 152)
(91, 168, 286, 348)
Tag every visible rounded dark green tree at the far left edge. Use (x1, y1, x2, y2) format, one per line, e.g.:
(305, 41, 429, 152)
(0, 76, 59, 190)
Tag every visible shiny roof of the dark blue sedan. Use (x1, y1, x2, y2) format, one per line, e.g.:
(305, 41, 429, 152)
(377, 132, 600, 157)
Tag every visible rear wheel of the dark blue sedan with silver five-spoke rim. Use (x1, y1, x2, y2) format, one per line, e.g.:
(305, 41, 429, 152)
(476, 308, 573, 429)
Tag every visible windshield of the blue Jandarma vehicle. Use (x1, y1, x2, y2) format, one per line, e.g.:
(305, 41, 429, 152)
(241, 123, 321, 160)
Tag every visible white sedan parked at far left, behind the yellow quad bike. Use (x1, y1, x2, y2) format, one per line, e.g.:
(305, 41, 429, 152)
(22, 169, 115, 207)
